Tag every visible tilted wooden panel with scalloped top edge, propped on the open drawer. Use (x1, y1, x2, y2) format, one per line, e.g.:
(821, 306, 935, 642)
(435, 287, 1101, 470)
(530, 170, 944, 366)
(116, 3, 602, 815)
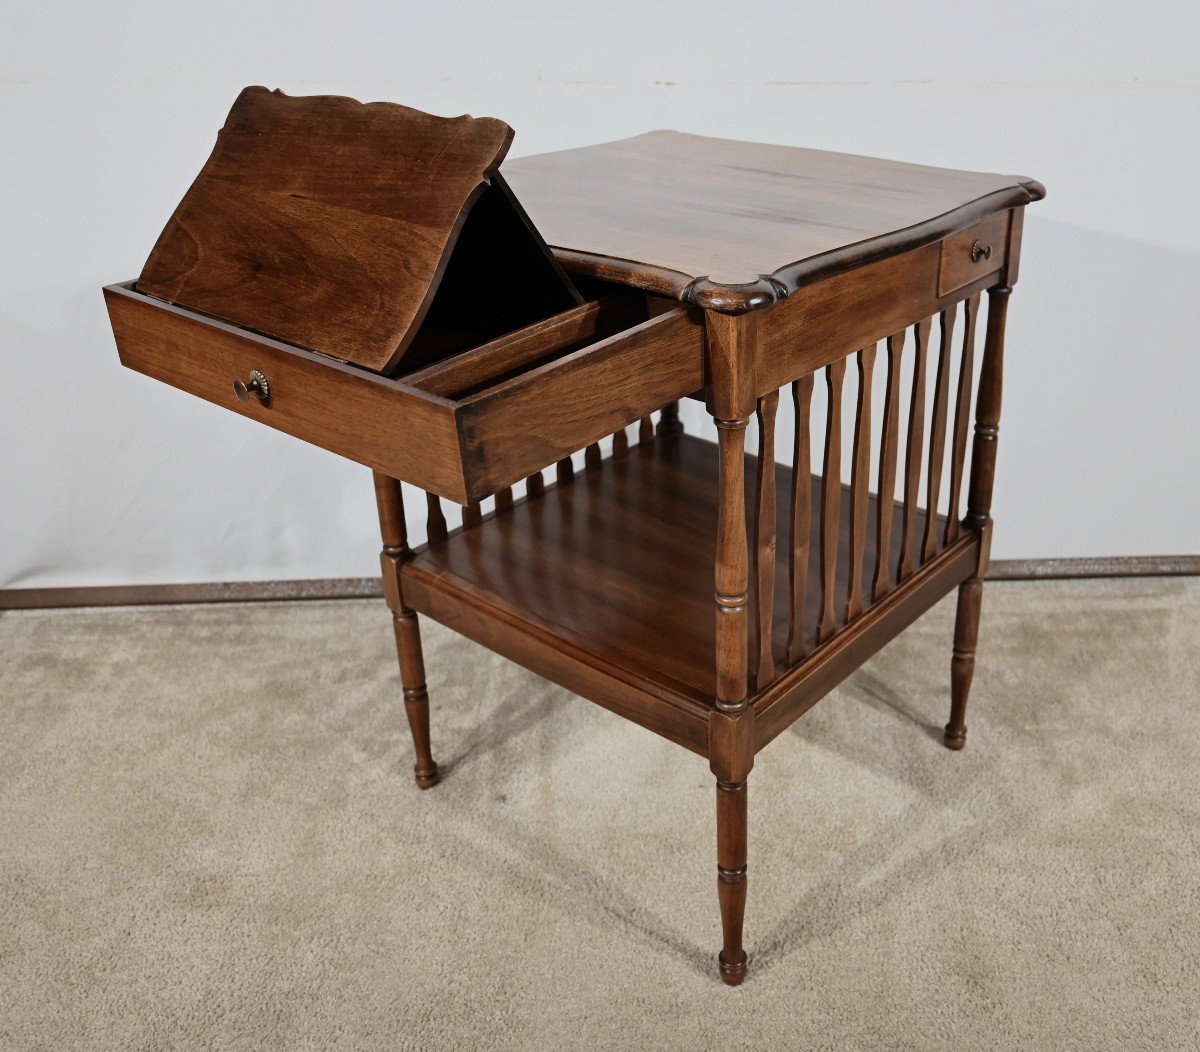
(138, 88, 512, 371)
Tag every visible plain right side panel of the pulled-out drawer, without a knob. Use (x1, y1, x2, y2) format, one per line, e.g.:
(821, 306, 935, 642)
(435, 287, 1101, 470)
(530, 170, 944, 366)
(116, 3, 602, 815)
(462, 307, 704, 499)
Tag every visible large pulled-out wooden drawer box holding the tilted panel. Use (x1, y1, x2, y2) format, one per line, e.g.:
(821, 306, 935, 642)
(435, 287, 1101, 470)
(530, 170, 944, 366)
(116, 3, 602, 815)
(104, 282, 704, 504)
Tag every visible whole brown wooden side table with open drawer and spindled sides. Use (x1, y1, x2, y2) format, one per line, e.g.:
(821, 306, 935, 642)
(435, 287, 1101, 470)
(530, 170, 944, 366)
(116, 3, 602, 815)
(106, 89, 1043, 984)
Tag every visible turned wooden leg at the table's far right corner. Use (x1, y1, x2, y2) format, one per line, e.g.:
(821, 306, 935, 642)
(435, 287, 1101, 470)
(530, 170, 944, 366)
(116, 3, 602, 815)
(942, 285, 1013, 749)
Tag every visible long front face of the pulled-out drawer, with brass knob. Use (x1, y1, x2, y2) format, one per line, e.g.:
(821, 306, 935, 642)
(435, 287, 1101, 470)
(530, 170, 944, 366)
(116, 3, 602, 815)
(104, 285, 466, 501)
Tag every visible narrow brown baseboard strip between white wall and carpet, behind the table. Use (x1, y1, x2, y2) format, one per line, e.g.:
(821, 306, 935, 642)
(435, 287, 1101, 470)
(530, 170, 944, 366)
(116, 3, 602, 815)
(0, 555, 1200, 611)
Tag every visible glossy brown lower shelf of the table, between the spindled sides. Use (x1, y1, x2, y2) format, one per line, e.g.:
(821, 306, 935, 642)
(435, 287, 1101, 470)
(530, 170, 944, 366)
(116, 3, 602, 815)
(403, 435, 974, 752)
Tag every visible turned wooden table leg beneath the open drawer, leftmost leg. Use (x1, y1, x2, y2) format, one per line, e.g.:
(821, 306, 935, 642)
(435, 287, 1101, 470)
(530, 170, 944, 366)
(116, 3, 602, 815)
(374, 471, 438, 789)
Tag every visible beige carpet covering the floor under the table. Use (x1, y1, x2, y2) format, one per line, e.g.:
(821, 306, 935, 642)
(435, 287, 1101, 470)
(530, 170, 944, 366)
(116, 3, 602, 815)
(0, 579, 1200, 1050)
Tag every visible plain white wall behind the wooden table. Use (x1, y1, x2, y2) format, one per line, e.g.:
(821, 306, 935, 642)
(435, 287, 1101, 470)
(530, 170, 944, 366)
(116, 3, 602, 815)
(0, 0, 1200, 587)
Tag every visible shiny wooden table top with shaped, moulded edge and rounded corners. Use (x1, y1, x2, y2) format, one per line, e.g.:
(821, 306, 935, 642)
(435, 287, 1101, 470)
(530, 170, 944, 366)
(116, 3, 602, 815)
(502, 131, 1045, 297)
